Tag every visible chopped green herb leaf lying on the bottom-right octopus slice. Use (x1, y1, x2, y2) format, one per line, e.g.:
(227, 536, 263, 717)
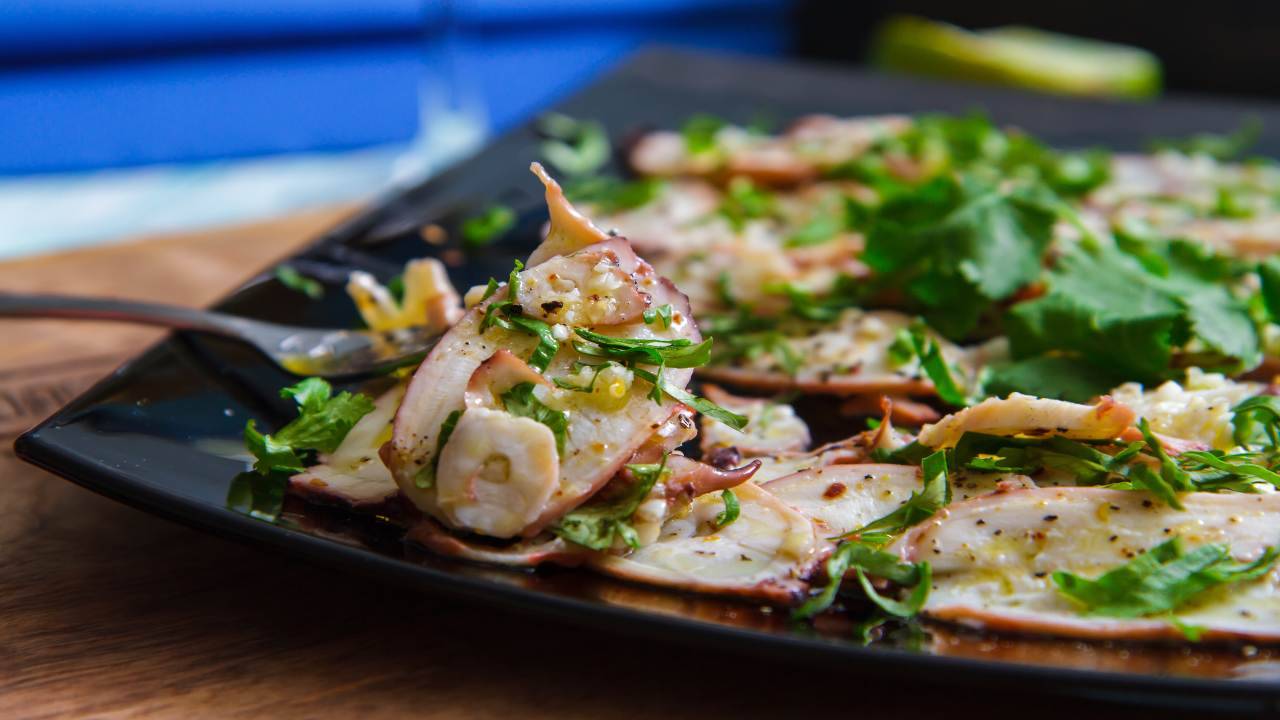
(1053, 537, 1280, 618)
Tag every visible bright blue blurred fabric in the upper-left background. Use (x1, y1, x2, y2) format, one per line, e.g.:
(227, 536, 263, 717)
(0, 0, 788, 174)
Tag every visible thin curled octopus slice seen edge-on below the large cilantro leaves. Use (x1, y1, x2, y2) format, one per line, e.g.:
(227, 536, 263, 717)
(916, 392, 1135, 447)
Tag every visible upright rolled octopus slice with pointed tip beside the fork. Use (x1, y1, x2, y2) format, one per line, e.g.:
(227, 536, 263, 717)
(384, 165, 701, 538)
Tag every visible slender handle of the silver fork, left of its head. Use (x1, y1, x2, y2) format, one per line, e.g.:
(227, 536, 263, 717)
(0, 292, 251, 337)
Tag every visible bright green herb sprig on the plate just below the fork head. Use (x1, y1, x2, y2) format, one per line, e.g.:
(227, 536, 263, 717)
(244, 378, 374, 474)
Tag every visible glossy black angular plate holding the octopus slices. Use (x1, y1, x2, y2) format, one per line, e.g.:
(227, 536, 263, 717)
(17, 46, 1280, 711)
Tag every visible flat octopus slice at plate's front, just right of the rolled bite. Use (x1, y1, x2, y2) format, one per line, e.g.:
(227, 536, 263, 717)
(590, 483, 827, 605)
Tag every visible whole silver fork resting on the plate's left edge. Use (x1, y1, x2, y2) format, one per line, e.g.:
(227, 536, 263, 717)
(0, 292, 439, 378)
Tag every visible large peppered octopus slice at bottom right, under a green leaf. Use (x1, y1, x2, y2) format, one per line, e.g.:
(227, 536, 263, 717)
(897, 487, 1280, 642)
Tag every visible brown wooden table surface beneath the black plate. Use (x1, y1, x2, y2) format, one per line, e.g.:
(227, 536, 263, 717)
(0, 209, 1198, 720)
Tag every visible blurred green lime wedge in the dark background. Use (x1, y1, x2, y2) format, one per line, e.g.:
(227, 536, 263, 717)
(872, 17, 1161, 99)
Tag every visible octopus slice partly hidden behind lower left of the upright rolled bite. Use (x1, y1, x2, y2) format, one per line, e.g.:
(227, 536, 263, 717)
(289, 383, 407, 507)
